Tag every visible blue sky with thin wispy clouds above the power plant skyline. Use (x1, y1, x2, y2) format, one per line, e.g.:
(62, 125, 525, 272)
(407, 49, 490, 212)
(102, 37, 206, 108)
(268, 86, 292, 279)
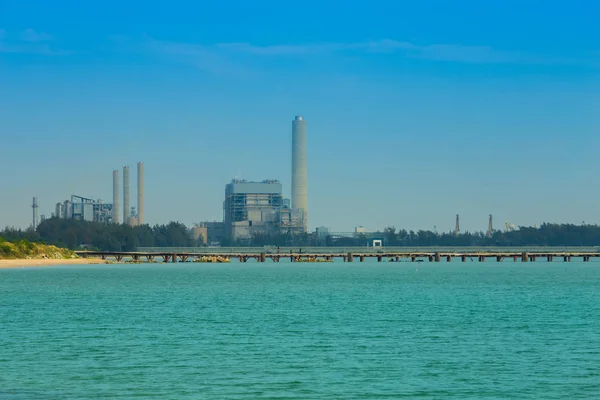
(0, 0, 600, 231)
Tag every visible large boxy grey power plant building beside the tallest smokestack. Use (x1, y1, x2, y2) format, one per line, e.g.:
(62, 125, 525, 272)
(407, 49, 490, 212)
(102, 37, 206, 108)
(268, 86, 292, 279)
(223, 179, 283, 242)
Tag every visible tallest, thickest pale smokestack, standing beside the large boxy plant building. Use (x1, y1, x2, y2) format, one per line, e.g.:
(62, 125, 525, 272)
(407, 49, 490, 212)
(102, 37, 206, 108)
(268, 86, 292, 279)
(292, 115, 308, 232)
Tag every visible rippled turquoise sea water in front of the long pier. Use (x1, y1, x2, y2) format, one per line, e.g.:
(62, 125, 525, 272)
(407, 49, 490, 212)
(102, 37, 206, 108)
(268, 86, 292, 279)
(0, 262, 600, 399)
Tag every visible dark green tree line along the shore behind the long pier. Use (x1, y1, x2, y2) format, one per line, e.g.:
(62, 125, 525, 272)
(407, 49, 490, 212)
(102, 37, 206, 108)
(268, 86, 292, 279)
(0, 218, 600, 251)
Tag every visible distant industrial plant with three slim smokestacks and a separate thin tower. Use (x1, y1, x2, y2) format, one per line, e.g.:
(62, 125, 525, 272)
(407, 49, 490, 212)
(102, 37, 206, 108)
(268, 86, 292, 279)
(50, 162, 144, 226)
